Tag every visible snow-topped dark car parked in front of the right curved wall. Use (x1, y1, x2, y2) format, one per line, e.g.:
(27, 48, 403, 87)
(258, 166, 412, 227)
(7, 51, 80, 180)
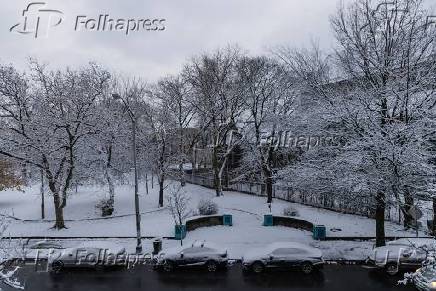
(242, 242, 324, 274)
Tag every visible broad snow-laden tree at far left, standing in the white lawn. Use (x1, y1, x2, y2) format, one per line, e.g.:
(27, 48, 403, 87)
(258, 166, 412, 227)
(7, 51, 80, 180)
(0, 61, 110, 229)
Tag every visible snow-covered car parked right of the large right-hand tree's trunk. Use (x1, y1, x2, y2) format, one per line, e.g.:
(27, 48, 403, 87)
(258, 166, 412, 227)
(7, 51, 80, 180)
(367, 239, 435, 276)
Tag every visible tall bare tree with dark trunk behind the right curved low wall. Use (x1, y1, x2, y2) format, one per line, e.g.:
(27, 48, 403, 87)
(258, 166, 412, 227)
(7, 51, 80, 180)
(238, 57, 294, 203)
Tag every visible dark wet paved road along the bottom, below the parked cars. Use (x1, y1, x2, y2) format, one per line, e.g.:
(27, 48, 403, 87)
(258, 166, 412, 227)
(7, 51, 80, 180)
(5, 265, 414, 291)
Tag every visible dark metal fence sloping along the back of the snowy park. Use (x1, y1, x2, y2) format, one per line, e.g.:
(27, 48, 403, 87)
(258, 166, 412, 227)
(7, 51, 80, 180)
(186, 174, 403, 223)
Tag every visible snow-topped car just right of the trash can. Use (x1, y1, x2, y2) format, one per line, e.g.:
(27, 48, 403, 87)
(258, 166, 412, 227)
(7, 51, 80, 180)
(155, 241, 228, 272)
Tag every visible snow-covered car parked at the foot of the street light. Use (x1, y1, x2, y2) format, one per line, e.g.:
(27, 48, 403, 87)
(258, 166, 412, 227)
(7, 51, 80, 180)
(48, 241, 127, 273)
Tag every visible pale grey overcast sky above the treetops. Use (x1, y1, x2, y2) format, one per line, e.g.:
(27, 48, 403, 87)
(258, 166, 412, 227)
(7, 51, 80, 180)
(0, 0, 434, 81)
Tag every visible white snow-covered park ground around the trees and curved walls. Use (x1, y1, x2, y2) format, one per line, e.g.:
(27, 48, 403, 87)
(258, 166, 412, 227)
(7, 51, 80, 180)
(0, 185, 426, 259)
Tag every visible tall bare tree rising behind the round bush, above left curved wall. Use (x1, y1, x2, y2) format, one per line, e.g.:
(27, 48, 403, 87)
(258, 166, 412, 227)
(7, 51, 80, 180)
(184, 47, 244, 196)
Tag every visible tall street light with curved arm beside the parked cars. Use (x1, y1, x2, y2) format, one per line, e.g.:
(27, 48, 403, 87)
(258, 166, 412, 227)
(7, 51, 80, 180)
(112, 93, 142, 254)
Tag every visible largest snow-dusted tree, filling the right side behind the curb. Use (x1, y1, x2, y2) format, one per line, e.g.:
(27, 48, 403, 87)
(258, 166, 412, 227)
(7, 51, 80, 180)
(280, 0, 436, 246)
